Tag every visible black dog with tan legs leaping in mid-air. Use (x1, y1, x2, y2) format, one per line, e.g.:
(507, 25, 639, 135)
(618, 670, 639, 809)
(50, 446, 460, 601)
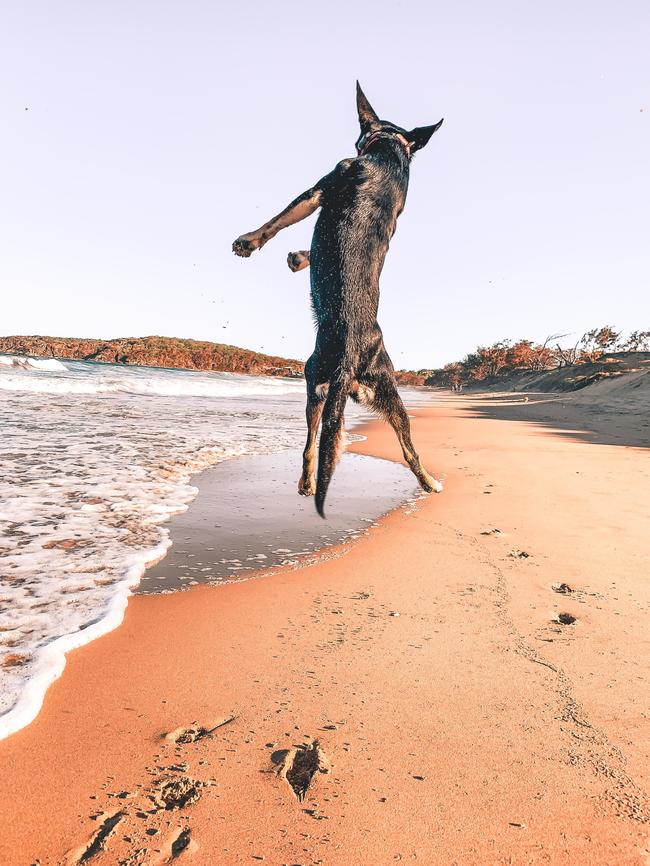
(233, 82, 442, 517)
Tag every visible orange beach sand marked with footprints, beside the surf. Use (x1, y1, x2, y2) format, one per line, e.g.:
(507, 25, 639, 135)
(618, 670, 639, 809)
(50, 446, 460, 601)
(0, 395, 650, 866)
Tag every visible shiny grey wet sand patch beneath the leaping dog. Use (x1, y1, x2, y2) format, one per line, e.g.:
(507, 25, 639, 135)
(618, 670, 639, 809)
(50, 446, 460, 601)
(136, 451, 419, 593)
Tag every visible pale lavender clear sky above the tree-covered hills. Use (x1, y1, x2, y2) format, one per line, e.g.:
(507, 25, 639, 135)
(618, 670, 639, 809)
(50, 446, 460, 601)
(0, 0, 650, 369)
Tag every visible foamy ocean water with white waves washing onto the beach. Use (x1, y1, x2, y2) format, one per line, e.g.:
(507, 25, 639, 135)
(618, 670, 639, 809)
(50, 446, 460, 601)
(0, 355, 422, 738)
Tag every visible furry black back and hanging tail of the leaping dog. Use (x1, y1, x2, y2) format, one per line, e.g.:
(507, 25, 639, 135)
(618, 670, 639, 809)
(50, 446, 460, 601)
(310, 145, 409, 514)
